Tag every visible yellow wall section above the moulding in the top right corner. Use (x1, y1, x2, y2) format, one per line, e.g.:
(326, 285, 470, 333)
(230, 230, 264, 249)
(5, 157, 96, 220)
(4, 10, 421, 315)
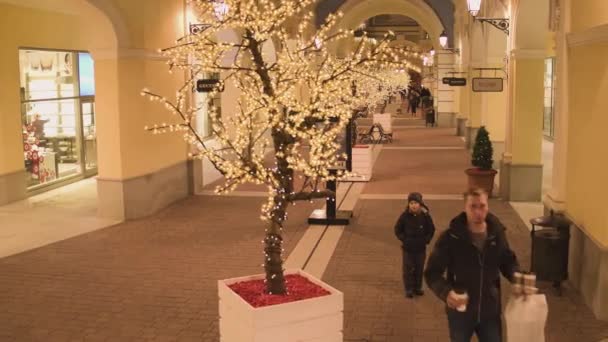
(570, 0, 608, 32)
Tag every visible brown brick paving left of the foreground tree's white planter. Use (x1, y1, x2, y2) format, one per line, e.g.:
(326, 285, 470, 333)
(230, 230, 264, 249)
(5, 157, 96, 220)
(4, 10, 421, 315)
(0, 196, 322, 342)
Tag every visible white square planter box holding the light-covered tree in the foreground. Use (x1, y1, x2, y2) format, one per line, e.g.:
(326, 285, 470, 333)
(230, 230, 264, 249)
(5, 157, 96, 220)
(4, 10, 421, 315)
(218, 270, 344, 342)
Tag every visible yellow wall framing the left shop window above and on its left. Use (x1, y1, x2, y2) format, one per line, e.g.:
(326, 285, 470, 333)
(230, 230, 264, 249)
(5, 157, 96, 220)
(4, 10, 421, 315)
(0, 4, 85, 175)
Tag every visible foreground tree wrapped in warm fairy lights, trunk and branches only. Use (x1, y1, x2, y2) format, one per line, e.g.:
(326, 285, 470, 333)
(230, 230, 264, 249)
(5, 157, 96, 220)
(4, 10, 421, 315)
(142, 0, 418, 294)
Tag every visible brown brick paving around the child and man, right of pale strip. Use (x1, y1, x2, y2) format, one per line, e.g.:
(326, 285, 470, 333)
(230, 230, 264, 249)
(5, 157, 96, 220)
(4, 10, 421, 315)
(323, 200, 608, 342)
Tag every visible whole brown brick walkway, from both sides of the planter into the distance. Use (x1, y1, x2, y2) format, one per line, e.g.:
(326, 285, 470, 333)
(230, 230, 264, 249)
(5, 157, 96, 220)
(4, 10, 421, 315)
(0, 123, 608, 342)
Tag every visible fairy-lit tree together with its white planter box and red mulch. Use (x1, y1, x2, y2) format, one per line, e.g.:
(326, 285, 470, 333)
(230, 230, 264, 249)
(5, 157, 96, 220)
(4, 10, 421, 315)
(141, 0, 416, 342)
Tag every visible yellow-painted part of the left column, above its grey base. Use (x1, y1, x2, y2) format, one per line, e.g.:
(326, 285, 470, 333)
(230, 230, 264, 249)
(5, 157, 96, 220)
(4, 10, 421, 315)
(96, 58, 187, 179)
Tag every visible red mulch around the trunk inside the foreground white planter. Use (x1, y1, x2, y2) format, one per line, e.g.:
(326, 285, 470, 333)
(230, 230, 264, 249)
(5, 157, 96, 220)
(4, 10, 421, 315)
(228, 274, 330, 308)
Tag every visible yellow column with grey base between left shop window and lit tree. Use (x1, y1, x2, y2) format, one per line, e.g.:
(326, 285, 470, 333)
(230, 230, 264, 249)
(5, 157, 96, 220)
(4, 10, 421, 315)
(92, 0, 192, 219)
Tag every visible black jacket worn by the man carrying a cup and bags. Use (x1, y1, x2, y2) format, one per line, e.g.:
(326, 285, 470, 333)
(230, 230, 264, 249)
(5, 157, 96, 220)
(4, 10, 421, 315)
(424, 212, 519, 321)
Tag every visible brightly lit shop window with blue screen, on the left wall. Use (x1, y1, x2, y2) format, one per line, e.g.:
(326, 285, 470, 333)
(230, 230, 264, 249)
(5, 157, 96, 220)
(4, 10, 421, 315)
(19, 49, 97, 189)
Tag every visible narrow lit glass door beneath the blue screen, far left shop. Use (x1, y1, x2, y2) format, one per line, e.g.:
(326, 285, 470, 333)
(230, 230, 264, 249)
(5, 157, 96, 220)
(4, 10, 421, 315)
(80, 97, 97, 177)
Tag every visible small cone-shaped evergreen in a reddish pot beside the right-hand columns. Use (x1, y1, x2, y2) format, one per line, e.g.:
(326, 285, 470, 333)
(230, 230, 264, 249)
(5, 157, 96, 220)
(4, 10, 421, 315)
(465, 126, 497, 196)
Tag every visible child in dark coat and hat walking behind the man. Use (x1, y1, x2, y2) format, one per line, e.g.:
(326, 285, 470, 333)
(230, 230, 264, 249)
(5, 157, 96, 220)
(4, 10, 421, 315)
(395, 192, 435, 298)
